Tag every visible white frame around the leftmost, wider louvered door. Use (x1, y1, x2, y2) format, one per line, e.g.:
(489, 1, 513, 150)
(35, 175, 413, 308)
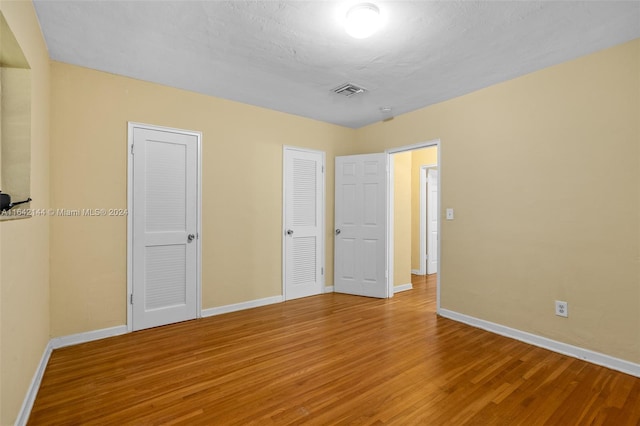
(125, 121, 202, 332)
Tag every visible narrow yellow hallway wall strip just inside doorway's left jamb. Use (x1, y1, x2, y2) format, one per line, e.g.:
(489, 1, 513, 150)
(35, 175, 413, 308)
(392, 152, 412, 286)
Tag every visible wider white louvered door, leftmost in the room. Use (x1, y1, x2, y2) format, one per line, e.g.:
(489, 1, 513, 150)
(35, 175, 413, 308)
(129, 124, 200, 330)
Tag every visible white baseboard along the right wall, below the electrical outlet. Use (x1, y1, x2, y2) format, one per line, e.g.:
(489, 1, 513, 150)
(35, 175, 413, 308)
(438, 309, 640, 377)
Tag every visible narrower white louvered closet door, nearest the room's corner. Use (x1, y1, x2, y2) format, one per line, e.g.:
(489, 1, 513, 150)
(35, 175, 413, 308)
(283, 147, 324, 300)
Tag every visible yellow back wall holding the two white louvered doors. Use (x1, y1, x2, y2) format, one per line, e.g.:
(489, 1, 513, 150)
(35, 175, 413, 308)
(51, 62, 355, 336)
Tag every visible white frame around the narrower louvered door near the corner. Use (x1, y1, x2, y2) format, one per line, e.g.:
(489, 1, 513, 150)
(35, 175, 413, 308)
(281, 145, 332, 300)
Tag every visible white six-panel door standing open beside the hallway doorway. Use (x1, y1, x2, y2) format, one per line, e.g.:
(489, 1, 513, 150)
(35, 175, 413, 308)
(334, 154, 390, 297)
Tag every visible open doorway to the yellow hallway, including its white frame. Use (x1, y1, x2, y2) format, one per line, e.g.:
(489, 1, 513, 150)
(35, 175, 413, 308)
(386, 139, 441, 311)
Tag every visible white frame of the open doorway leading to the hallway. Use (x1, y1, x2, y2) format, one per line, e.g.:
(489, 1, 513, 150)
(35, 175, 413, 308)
(385, 139, 442, 313)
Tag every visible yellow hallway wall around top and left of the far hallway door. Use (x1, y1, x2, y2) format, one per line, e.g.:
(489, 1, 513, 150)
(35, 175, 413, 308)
(411, 146, 438, 270)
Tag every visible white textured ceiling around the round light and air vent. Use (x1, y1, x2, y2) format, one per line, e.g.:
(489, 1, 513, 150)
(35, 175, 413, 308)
(35, 0, 640, 128)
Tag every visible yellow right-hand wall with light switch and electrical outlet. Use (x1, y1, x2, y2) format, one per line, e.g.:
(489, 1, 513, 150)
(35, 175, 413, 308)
(356, 40, 640, 363)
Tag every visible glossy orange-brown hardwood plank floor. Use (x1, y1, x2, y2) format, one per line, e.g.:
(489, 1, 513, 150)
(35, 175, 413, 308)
(29, 276, 640, 426)
